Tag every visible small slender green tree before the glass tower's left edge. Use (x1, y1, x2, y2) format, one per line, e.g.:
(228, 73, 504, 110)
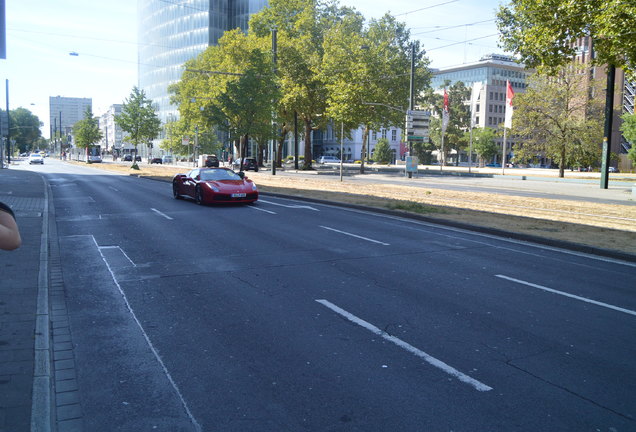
(115, 86, 161, 167)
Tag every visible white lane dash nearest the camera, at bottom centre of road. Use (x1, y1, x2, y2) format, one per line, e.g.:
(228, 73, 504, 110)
(316, 300, 492, 392)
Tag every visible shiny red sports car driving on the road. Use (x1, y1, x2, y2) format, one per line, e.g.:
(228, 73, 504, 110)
(172, 168, 258, 204)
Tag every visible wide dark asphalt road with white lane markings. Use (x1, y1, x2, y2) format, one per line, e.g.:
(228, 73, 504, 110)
(14, 160, 636, 431)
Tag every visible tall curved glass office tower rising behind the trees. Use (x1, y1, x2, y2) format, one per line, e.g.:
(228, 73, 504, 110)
(137, 0, 267, 123)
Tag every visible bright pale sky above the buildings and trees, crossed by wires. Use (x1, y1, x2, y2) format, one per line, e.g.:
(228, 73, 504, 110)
(0, 0, 503, 138)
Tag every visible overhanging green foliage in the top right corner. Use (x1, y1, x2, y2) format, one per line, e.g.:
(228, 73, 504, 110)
(497, 0, 636, 73)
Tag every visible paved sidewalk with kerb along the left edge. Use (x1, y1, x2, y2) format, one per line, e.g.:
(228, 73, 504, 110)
(0, 169, 50, 432)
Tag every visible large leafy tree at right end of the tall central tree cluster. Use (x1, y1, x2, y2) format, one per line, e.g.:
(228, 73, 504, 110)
(321, 13, 431, 173)
